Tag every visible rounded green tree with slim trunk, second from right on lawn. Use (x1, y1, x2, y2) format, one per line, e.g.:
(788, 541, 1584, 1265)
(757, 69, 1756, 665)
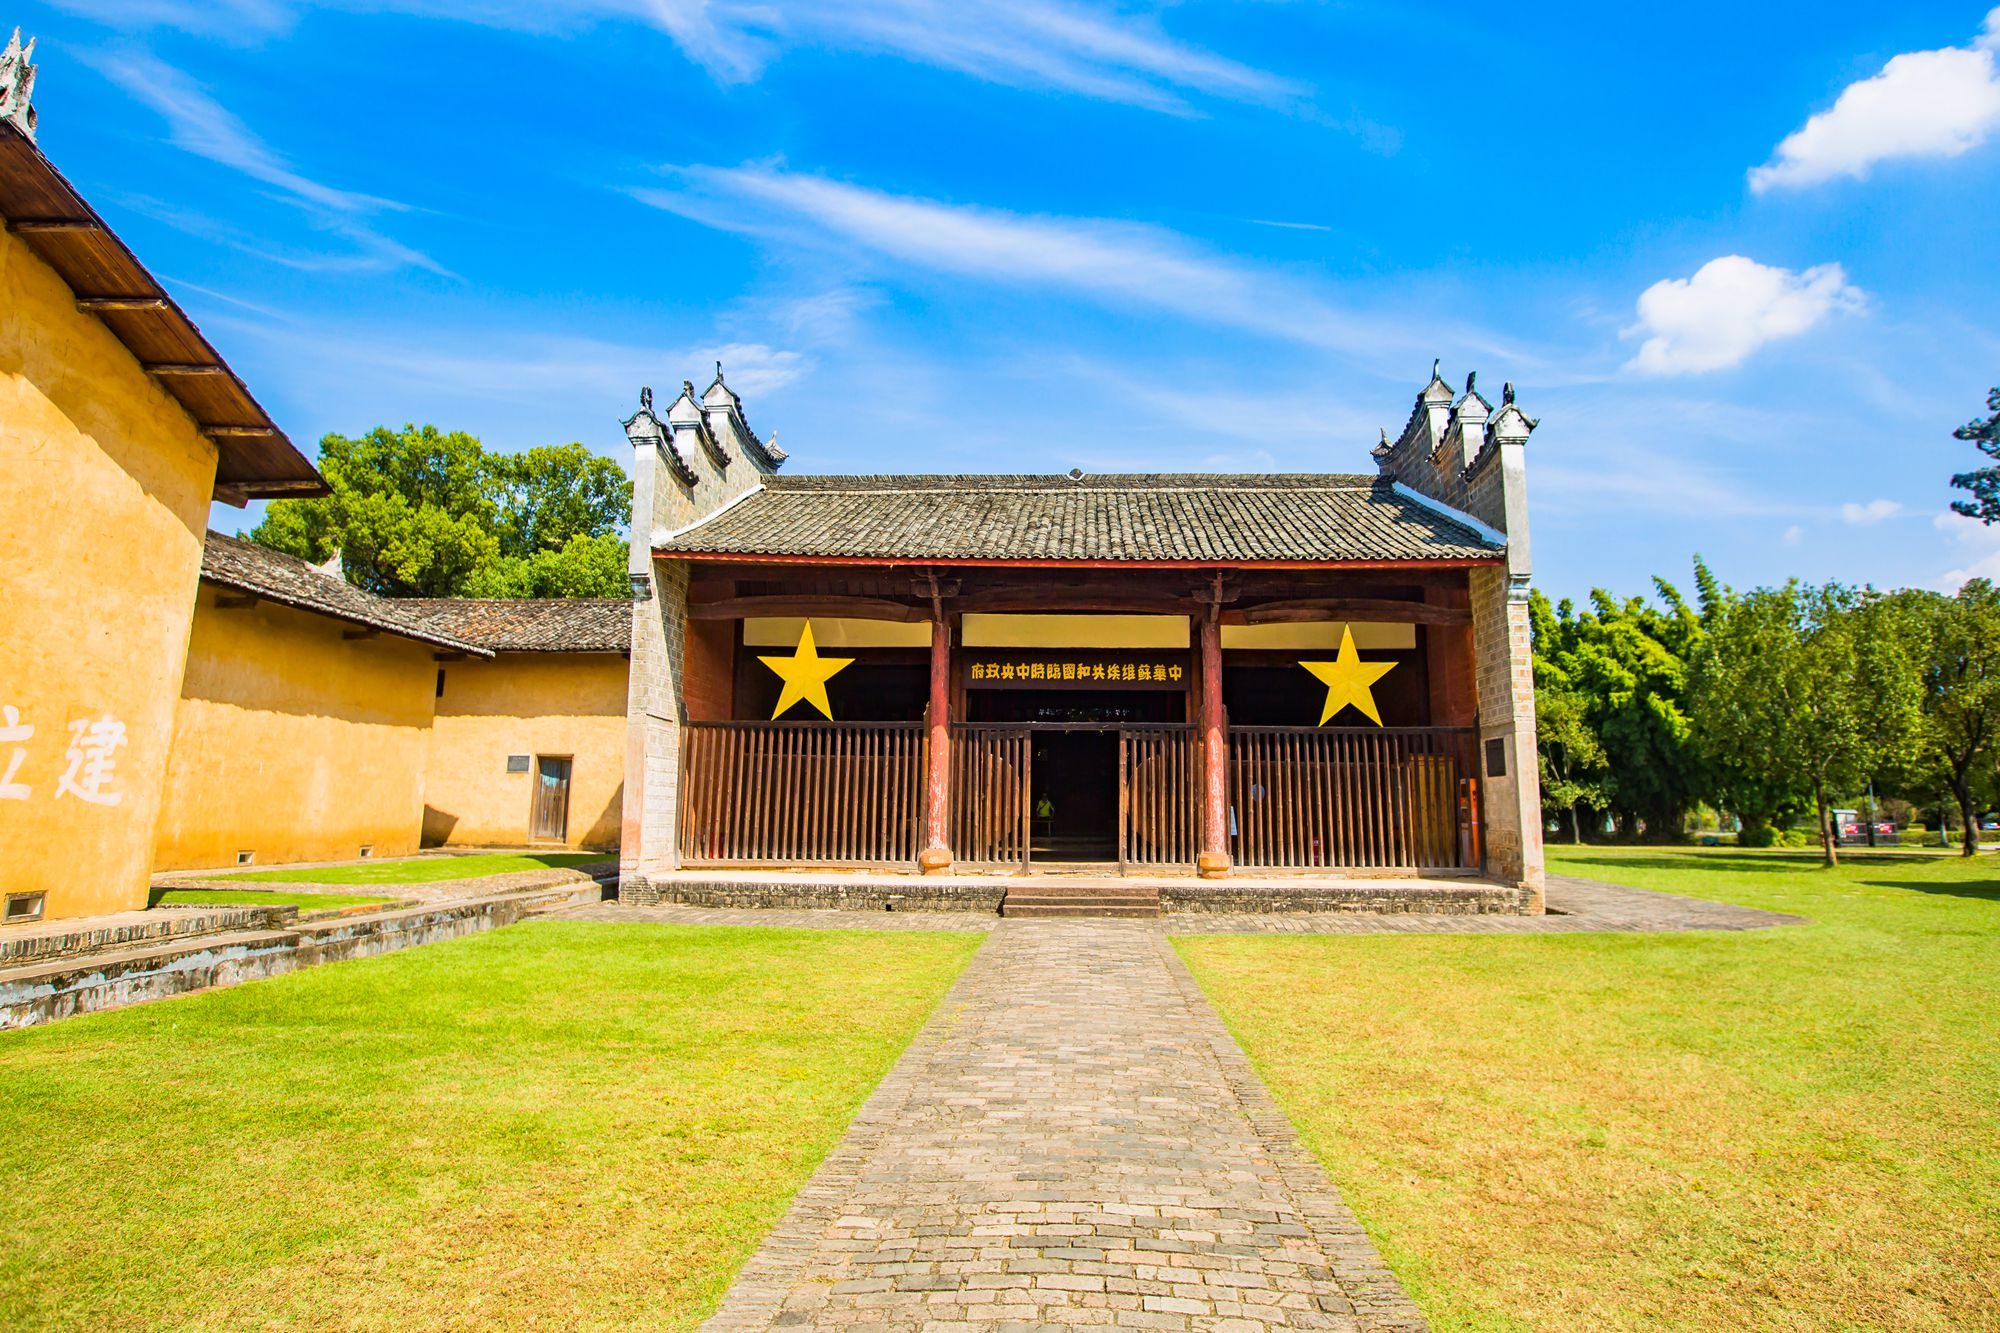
(1694, 582, 1918, 865)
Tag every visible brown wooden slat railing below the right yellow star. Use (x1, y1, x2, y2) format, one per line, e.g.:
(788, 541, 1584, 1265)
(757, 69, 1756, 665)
(1228, 727, 1478, 871)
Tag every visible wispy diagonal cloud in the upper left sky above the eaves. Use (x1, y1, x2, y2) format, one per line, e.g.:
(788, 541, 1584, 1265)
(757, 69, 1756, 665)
(92, 50, 448, 276)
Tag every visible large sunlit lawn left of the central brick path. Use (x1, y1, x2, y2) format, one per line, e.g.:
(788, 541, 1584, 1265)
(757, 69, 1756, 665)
(0, 921, 980, 1331)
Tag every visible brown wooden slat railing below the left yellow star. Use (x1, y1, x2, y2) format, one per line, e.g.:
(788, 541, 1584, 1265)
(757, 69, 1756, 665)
(680, 723, 924, 865)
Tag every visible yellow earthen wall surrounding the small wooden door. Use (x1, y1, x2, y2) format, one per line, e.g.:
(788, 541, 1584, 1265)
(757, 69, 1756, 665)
(424, 652, 626, 851)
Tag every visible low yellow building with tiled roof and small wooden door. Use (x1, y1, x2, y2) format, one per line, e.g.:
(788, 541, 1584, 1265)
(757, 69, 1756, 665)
(152, 532, 632, 871)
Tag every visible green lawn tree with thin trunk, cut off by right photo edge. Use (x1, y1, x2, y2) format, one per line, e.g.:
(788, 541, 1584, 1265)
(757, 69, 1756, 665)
(1884, 578, 2000, 857)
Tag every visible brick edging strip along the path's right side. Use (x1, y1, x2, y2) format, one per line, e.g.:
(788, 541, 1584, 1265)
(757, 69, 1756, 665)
(1154, 931, 1430, 1333)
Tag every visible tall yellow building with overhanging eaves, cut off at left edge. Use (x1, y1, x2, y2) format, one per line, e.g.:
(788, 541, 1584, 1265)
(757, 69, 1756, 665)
(0, 34, 324, 921)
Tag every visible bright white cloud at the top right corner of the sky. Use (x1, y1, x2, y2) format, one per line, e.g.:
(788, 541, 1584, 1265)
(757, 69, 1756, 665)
(1750, 8, 2000, 194)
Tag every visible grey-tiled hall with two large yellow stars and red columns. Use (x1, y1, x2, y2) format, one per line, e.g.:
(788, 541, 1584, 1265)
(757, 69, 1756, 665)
(622, 358, 1542, 911)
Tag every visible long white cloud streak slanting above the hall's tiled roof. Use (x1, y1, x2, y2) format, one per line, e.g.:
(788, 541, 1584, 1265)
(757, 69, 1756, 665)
(632, 166, 1436, 352)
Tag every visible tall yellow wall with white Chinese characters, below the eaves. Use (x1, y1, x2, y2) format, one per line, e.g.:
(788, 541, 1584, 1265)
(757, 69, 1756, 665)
(0, 232, 216, 919)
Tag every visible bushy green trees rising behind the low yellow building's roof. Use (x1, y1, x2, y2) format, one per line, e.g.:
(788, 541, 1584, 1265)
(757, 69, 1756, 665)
(250, 426, 632, 596)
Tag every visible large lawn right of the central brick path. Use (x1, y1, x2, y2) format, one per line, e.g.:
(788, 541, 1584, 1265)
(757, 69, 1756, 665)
(1178, 849, 2000, 1331)
